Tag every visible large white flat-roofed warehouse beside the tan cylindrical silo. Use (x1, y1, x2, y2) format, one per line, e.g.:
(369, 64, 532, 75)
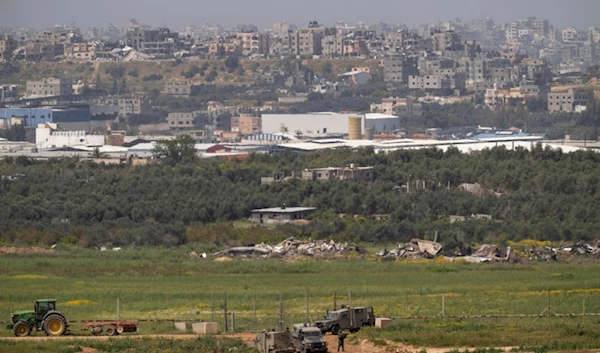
(262, 113, 364, 135)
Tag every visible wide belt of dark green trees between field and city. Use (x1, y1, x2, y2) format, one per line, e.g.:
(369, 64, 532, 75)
(0, 145, 600, 251)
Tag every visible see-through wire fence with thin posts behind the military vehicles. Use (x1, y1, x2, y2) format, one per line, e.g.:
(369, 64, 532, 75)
(0, 290, 600, 332)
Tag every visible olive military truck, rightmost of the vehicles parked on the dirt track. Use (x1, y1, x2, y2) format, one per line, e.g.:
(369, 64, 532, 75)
(315, 306, 375, 335)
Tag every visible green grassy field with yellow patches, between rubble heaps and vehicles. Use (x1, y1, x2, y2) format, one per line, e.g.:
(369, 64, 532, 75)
(0, 246, 600, 351)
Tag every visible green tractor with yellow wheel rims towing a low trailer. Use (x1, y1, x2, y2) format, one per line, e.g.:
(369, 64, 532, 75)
(6, 299, 68, 337)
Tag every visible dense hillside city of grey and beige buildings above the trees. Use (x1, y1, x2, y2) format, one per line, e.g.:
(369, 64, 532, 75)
(0, 17, 600, 157)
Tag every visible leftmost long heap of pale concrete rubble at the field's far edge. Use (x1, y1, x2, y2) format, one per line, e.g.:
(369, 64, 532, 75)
(213, 237, 359, 258)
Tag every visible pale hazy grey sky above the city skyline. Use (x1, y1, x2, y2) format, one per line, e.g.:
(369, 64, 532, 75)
(0, 0, 600, 30)
